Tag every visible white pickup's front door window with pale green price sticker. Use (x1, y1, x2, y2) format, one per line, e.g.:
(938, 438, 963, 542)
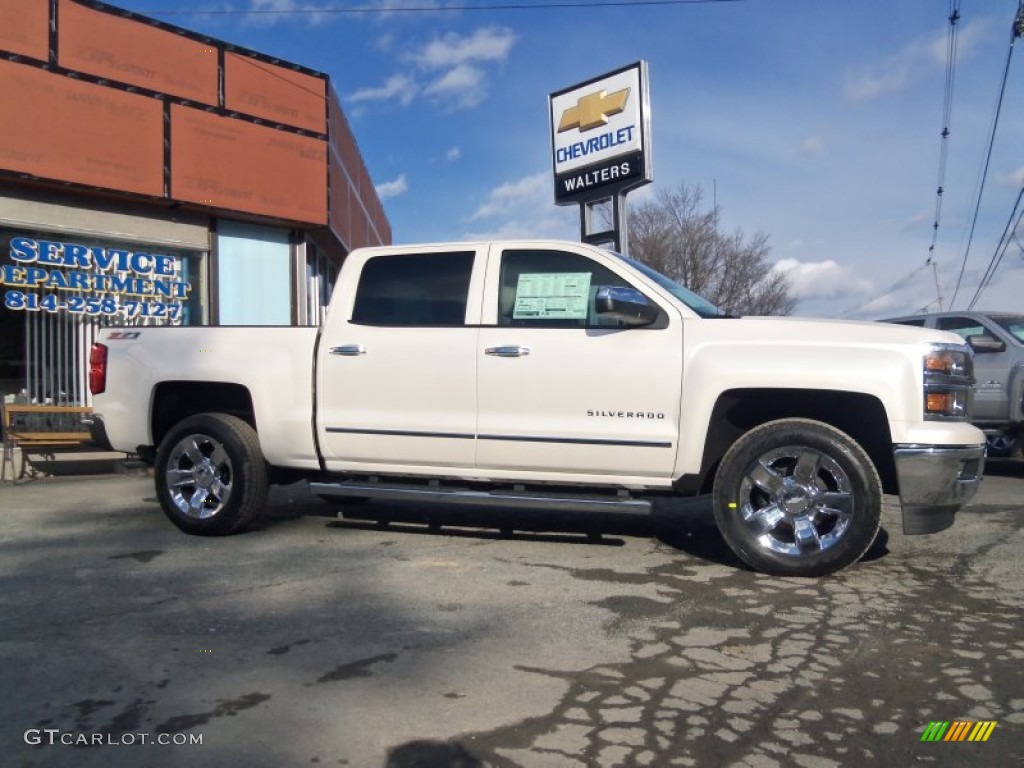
(498, 250, 633, 328)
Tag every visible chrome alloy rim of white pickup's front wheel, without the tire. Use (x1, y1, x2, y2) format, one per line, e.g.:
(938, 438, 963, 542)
(739, 445, 854, 557)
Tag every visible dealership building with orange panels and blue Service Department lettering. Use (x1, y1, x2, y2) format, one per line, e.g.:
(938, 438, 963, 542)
(0, 0, 391, 404)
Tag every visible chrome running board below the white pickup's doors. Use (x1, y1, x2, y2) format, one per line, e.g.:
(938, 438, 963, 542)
(309, 480, 651, 515)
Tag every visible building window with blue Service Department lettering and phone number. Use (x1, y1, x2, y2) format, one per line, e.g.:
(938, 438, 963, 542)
(0, 230, 206, 404)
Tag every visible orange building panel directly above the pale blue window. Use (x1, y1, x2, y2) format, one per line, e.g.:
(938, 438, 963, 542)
(171, 104, 328, 225)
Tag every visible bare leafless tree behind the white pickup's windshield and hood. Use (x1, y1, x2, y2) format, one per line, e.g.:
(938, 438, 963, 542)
(629, 183, 797, 315)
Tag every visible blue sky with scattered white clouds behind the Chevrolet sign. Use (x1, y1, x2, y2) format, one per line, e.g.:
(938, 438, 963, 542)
(113, 0, 1024, 318)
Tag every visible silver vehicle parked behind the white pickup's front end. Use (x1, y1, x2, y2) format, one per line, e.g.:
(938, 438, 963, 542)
(883, 311, 1024, 457)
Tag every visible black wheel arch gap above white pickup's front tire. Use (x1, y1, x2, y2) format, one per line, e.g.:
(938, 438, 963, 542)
(680, 388, 897, 494)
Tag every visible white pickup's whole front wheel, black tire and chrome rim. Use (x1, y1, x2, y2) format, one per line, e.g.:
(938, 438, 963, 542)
(713, 419, 882, 577)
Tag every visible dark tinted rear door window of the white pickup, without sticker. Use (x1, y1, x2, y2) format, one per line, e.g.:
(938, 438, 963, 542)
(352, 251, 475, 326)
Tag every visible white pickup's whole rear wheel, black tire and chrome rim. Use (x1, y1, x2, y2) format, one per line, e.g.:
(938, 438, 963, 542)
(155, 414, 267, 536)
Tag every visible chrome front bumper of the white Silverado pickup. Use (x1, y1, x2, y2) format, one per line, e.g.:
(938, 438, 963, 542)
(893, 444, 985, 536)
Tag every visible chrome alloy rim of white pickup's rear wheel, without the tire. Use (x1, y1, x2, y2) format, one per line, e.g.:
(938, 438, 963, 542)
(164, 434, 232, 520)
